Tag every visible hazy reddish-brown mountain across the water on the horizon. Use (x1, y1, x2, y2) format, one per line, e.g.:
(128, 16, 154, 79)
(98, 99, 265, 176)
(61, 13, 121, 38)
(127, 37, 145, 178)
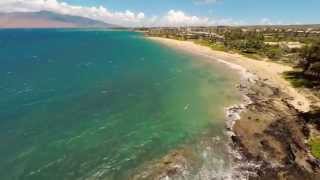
(0, 11, 120, 28)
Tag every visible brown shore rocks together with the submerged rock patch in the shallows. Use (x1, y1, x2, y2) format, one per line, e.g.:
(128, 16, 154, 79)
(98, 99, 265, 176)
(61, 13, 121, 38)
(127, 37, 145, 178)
(132, 74, 320, 180)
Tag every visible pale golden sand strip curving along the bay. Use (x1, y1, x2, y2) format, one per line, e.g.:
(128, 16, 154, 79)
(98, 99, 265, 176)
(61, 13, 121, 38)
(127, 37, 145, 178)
(149, 37, 311, 112)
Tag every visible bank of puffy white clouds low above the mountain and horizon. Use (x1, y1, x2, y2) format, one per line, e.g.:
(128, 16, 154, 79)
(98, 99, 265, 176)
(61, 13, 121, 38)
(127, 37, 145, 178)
(0, 0, 239, 26)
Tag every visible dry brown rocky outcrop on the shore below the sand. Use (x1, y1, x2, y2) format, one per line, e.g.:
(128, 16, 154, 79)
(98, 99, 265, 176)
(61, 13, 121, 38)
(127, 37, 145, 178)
(231, 75, 320, 180)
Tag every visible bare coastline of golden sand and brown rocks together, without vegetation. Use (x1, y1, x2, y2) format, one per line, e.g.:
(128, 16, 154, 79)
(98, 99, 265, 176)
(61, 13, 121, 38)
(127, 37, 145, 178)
(147, 37, 320, 179)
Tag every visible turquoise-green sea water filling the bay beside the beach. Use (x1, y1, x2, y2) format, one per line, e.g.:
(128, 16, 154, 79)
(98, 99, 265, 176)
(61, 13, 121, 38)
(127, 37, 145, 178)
(0, 29, 237, 180)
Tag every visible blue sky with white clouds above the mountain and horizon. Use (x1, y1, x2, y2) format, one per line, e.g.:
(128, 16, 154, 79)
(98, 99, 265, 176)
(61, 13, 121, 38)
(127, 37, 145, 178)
(0, 0, 320, 27)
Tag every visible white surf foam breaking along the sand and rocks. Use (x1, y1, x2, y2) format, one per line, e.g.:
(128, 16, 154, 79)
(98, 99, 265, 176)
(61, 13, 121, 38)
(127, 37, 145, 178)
(159, 53, 260, 180)
